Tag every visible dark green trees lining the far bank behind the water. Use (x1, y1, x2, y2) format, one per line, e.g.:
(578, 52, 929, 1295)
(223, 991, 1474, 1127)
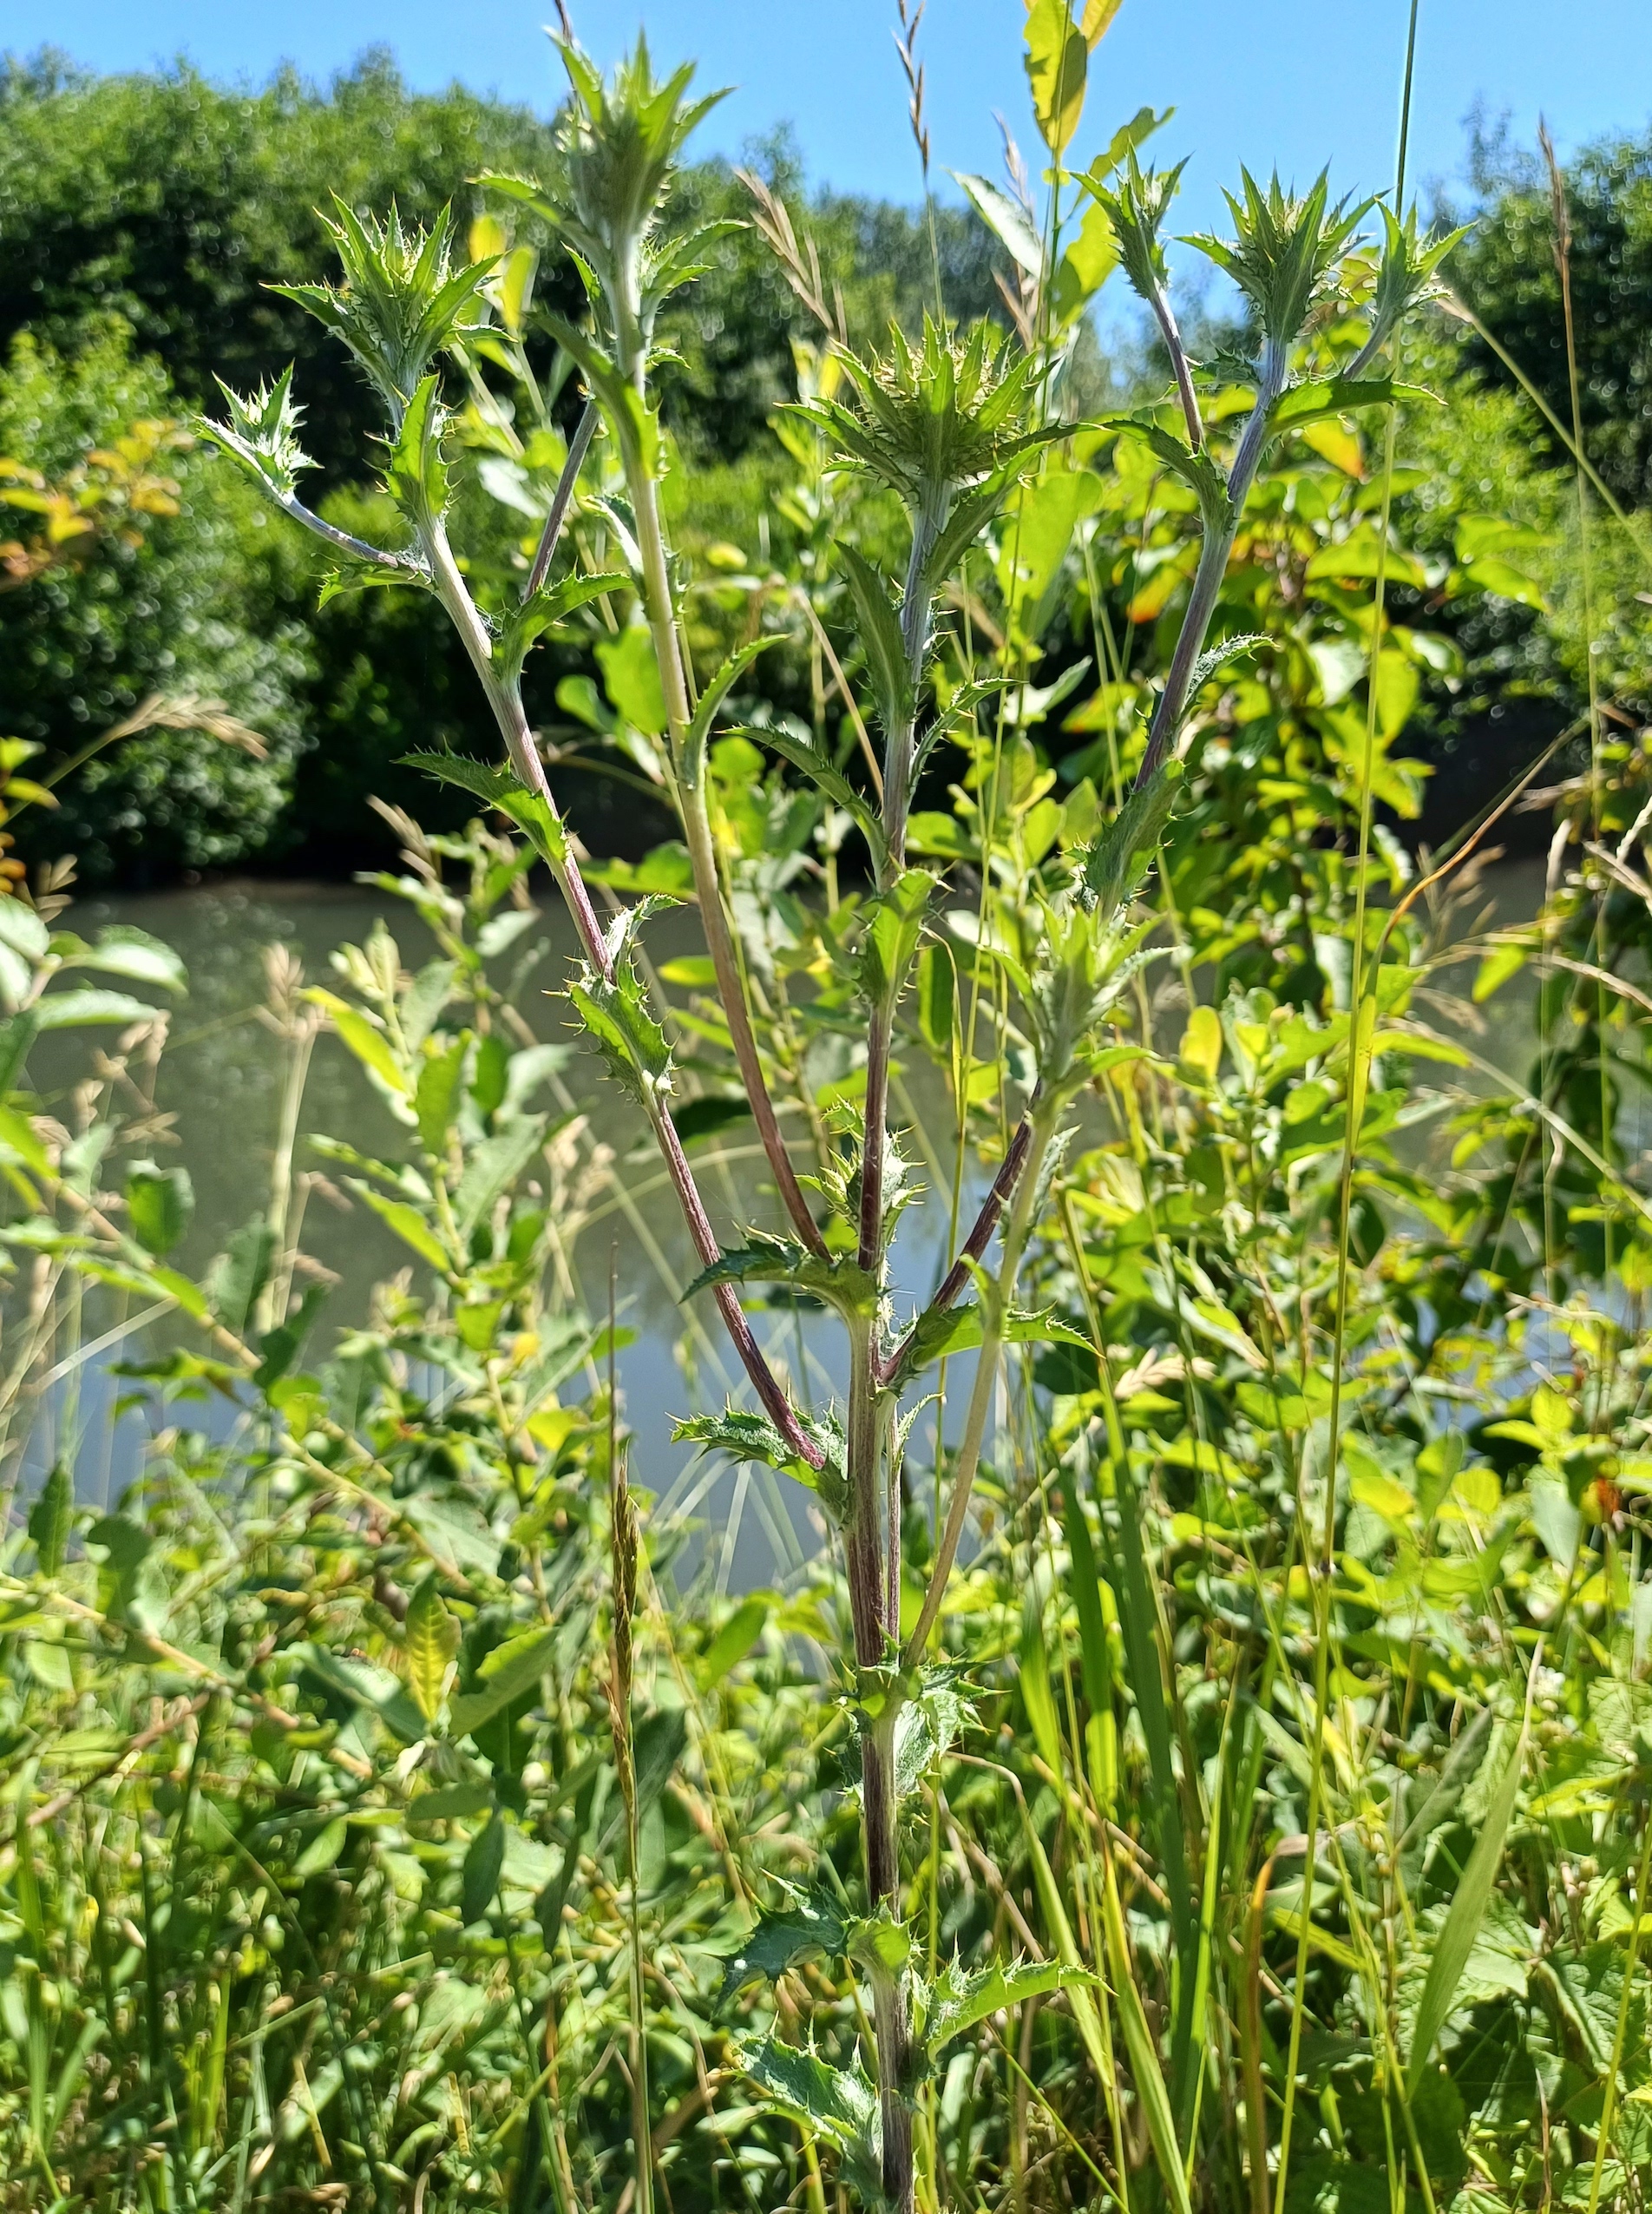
(0, 56, 1652, 881)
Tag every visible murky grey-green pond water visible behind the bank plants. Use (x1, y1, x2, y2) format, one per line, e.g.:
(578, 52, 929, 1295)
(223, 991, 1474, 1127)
(29, 861, 1568, 1587)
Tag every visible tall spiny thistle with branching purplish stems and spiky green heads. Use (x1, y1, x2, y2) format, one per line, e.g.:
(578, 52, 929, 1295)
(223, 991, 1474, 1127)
(208, 25, 1444, 2214)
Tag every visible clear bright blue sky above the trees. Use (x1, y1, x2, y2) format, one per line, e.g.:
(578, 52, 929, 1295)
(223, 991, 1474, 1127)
(0, 0, 1652, 242)
